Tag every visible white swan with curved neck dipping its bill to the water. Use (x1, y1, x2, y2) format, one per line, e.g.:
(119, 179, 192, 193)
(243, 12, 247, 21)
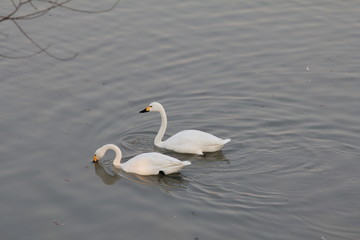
(93, 144, 191, 175)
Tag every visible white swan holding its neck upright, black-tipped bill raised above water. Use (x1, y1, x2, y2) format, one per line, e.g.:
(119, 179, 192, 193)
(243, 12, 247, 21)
(140, 102, 231, 155)
